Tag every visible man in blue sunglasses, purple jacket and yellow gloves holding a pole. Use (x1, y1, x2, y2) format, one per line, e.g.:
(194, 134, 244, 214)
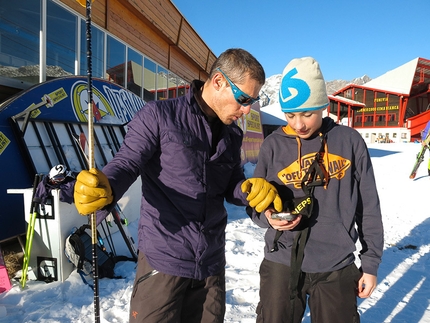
(74, 49, 281, 323)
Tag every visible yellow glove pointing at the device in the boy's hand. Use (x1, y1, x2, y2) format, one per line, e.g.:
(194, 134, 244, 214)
(241, 178, 282, 212)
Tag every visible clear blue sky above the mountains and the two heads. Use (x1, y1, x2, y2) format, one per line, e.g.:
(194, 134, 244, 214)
(172, 0, 430, 81)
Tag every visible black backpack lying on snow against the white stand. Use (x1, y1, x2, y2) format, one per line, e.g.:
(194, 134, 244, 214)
(64, 224, 116, 281)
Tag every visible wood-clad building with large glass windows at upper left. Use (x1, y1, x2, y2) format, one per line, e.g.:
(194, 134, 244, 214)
(0, 0, 216, 102)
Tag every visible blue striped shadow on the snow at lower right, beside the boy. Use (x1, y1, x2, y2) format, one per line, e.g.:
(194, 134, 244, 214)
(358, 219, 430, 323)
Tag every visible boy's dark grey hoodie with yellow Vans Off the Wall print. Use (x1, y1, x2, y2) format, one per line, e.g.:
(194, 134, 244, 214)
(252, 118, 383, 275)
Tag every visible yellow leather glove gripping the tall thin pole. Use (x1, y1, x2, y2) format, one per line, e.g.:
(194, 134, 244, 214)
(74, 168, 113, 215)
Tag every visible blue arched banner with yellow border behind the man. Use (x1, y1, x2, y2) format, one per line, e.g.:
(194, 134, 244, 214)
(0, 76, 145, 240)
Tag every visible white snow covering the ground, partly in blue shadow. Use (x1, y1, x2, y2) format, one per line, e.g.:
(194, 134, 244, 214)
(0, 143, 430, 323)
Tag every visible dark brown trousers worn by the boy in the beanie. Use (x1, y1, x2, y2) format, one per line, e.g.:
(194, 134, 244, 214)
(256, 259, 361, 323)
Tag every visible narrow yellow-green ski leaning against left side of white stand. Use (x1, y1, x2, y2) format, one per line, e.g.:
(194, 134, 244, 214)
(20, 174, 43, 288)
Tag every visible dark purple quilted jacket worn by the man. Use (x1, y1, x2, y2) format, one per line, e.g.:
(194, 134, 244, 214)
(103, 81, 247, 280)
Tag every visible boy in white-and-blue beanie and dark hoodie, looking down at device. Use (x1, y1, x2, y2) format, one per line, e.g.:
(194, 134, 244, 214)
(248, 57, 384, 323)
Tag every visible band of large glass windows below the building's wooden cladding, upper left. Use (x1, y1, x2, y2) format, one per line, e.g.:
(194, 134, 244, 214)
(0, 0, 189, 101)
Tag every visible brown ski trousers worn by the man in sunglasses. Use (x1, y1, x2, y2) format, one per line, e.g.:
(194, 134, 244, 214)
(129, 252, 225, 323)
